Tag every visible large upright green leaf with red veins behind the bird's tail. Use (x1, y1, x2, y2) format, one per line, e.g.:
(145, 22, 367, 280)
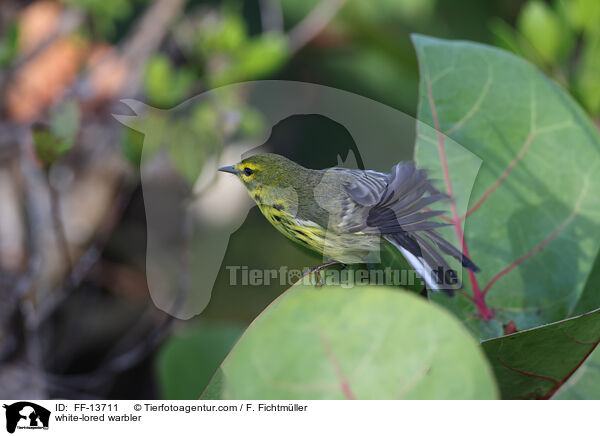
(414, 36, 600, 339)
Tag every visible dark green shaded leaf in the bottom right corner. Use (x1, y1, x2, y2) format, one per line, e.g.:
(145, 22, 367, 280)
(481, 309, 600, 399)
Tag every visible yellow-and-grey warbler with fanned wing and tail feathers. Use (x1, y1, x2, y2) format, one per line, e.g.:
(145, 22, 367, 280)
(219, 153, 479, 295)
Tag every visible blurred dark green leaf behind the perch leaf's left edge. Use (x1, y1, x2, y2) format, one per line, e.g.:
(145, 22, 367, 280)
(156, 324, 243, 400)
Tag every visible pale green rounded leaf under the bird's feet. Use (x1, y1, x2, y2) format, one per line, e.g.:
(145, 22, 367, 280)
(204, 285, 496, 399)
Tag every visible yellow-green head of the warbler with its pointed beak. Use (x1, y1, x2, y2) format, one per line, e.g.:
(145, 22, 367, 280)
(219, 153, 304, 193)
